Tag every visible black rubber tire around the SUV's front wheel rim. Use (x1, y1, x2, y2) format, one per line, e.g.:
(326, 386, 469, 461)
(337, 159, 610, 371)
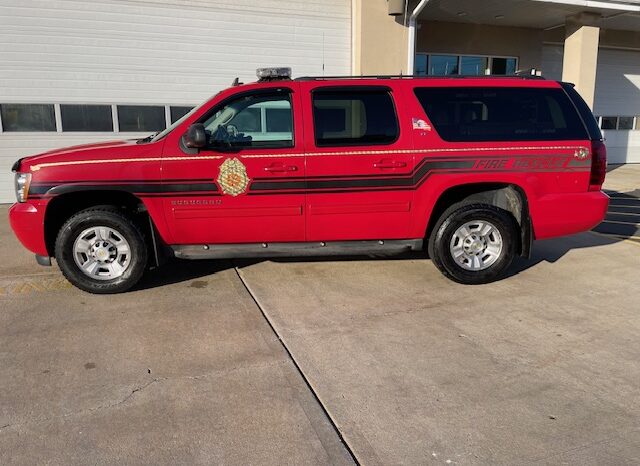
(55, 206, 147, 294)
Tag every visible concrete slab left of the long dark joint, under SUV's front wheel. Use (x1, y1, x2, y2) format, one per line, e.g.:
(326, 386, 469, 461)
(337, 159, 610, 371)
(0, 209, 351, 465)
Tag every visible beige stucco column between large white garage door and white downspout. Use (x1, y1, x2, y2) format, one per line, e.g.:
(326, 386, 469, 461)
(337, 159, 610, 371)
(352, 0, 407, 75)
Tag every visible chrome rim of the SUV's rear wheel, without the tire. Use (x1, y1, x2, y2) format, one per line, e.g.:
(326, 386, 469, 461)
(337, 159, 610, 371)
(449, 220, 503, 272)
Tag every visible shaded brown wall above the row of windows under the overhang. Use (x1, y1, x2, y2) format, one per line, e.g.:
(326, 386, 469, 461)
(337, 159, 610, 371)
(416, 21, 542, 69)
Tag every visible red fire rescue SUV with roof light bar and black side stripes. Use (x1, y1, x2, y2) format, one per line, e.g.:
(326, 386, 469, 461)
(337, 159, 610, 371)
(10, 69, 608, 293)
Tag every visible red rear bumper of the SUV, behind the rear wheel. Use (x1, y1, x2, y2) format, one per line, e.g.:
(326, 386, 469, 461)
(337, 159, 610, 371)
(529, 191, 609, 239)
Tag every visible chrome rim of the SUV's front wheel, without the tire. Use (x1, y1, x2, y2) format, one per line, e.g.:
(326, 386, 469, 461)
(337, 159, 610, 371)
(73, 226, 131, 280)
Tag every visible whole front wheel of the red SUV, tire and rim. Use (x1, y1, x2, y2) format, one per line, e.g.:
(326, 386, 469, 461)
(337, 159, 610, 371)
(55, 207, 147, 294)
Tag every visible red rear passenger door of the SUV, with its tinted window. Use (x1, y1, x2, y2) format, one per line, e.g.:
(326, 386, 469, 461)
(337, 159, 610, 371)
(301, 81, 414, 241)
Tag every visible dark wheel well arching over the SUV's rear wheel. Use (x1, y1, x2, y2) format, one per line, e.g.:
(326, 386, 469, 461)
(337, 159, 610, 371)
(425, 183, 533, 255)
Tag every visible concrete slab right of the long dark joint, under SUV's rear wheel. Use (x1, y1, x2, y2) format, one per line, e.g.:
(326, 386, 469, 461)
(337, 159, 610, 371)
(240, 233, 640, 465)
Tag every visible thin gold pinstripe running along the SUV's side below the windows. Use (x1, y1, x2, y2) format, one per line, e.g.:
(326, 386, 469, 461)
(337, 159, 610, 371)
(31, 146, 588, 171)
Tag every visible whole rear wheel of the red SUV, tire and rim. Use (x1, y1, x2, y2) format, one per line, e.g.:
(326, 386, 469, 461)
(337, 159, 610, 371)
(429, 204, 519, 284)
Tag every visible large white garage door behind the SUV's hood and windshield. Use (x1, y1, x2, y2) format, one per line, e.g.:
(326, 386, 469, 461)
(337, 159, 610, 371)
(0, 0, 351, 202)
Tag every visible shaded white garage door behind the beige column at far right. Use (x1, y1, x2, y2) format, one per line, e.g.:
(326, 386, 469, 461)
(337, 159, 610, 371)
(542, 45, 640, 164)
